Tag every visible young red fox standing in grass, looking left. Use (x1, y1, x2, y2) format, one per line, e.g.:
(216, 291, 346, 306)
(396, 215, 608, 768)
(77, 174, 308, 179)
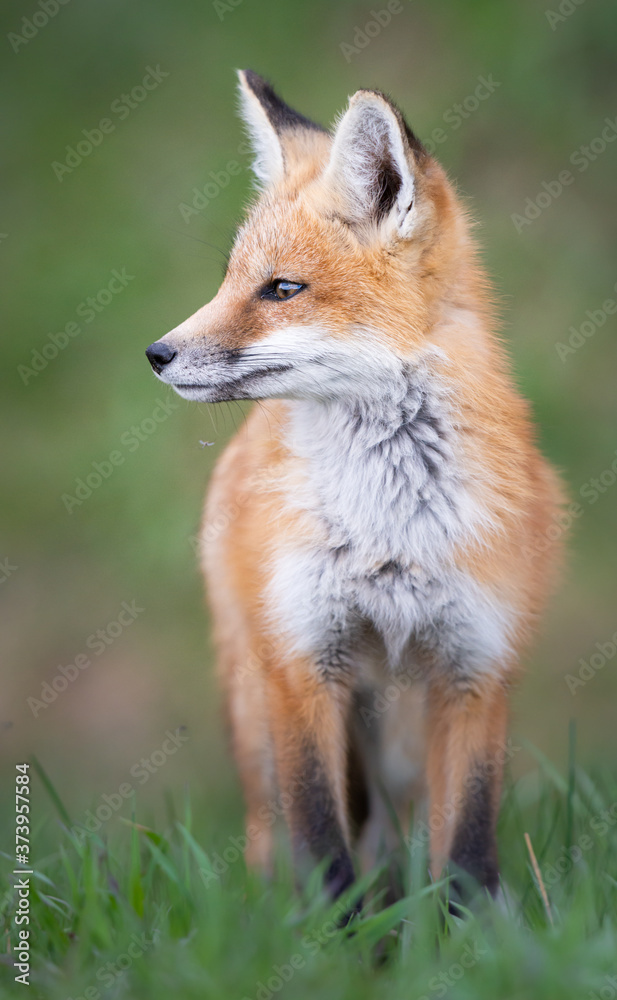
(146, 71, 560, 896)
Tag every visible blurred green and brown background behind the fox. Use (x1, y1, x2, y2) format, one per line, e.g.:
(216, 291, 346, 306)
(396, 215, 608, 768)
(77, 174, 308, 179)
(0, 0, 617, 823)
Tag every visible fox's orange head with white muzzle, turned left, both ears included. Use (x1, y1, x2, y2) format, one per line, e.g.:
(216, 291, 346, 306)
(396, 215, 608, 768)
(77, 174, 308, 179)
(146, 70, 477, 402)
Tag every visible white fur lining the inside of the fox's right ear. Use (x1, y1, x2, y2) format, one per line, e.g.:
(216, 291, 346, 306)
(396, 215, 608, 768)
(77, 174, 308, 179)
(324, 93, 415, 237)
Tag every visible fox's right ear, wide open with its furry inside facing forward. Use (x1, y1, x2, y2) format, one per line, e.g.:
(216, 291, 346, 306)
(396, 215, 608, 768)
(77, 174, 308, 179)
(325, 90, 426, 238)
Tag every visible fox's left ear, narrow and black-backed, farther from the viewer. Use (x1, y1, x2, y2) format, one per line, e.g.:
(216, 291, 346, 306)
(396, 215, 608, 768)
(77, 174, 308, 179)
(238, 69, 323, 187)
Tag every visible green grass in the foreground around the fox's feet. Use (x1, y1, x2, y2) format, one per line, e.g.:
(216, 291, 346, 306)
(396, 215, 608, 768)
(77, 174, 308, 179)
(2, 757, 617, 1000)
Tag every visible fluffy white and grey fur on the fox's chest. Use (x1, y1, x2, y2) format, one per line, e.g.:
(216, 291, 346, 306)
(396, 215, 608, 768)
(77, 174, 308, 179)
(268, 367, 512, 677)
